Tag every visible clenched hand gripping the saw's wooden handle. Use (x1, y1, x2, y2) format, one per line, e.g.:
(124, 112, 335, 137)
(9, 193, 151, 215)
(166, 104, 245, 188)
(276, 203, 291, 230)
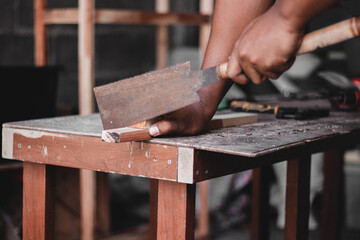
(227, 4, 304, 84)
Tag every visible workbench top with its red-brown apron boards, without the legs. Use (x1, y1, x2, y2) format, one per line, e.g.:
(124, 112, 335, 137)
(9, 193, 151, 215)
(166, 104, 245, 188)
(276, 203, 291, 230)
(2, 112, 360, 184)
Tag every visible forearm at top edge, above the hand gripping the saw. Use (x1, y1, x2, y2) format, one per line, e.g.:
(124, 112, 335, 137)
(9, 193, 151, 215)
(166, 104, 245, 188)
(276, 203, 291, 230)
(272, 0, 338, 30)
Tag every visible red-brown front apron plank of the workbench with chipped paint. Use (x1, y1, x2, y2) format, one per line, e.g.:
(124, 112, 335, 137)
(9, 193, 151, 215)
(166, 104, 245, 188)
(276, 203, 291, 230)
(11, 130, 178, 181)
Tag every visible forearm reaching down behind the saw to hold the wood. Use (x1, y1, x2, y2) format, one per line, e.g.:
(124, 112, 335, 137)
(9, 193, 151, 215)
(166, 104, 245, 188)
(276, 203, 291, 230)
(199, 0, 272, 115)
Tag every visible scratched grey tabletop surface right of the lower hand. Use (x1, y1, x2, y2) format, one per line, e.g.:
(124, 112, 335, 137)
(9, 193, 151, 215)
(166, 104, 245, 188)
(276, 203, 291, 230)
(150, 112, 360, 157)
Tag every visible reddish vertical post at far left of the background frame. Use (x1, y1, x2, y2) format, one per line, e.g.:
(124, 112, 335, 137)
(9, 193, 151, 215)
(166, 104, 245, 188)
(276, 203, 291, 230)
(34, 0, 48, 67)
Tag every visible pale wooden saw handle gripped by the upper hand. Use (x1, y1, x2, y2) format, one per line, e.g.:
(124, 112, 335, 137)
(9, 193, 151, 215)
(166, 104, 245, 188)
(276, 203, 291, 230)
(216, 17, 360, 79)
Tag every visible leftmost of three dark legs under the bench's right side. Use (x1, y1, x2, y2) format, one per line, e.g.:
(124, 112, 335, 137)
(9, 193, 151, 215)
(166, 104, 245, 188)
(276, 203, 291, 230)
(250, 167, 270, 240)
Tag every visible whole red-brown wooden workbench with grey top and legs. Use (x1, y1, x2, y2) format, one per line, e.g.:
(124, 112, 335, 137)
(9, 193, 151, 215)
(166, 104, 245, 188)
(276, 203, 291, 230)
(2, 113, 360, 240)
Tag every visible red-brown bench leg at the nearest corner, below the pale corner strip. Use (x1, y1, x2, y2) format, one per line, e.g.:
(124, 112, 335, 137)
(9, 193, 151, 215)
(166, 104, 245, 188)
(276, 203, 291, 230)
(157, 180, 196, 240)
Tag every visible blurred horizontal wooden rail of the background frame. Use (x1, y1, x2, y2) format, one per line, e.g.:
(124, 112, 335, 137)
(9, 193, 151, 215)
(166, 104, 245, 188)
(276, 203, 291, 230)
(44, 8, 210, 25)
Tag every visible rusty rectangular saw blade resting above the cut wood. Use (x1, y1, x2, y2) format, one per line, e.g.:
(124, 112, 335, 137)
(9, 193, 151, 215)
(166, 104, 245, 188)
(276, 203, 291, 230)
(94, 62, 221, 130)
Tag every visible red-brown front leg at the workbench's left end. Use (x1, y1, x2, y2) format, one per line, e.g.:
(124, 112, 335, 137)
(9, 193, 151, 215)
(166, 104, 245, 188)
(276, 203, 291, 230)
(23, 162, 54, 240)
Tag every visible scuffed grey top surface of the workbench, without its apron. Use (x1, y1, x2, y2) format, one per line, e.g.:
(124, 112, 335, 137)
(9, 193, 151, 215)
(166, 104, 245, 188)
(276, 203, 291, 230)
(3, 112, 360, 157)
